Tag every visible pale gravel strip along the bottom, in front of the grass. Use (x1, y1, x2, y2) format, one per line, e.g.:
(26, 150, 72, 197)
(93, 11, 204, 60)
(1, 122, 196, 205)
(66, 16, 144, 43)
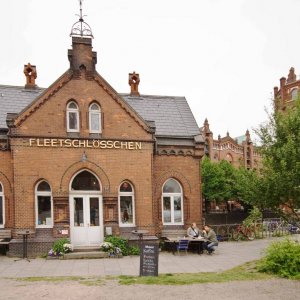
(0, 279, 300, 300)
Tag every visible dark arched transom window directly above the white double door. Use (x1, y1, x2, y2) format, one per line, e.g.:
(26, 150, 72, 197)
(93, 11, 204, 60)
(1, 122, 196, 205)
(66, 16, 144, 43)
(71, 171, 100, 191)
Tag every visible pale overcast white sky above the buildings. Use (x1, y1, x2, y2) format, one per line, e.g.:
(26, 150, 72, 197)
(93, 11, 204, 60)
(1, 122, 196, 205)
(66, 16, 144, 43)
(0, 0, 300, 141)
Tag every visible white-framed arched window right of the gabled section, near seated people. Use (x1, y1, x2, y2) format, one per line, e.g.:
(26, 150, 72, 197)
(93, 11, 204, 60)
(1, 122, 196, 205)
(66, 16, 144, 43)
(162, 178, 183, 225)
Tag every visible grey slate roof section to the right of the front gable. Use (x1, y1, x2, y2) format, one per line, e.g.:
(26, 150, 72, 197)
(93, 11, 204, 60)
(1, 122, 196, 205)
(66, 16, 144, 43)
(120, 94, 200, 137)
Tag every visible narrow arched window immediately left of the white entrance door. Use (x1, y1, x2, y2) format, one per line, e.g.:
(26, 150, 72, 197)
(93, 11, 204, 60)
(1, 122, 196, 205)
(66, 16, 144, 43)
(35, 181, 53, 228)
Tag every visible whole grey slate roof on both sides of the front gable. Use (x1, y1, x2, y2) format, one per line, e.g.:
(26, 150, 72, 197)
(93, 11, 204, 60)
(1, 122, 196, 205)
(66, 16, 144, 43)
(0, 80, 200, 137)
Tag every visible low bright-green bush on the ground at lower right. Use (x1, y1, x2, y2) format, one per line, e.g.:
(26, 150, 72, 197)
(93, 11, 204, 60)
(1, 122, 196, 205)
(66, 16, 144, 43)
(258, 239, 300, 279)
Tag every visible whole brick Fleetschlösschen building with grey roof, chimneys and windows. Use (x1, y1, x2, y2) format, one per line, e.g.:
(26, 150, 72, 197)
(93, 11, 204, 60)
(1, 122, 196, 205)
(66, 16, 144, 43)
(0, 20, 204, 255)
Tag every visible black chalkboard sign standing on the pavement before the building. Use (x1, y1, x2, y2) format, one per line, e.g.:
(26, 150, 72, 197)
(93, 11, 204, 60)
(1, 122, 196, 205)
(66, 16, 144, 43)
(140, 244, 158, 276)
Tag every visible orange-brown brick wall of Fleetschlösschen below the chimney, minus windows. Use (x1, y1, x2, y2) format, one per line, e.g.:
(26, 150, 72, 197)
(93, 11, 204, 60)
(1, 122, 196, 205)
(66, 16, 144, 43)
(0, 73, 202, 255)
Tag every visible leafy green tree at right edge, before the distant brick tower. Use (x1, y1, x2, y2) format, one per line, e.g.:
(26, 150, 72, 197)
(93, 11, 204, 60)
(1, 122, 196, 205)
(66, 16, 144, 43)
(256, 99, 300, 218)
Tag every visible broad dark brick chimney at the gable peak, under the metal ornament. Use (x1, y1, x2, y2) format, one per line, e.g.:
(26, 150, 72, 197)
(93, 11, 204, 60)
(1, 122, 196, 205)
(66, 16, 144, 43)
(68, 36, 97, 73)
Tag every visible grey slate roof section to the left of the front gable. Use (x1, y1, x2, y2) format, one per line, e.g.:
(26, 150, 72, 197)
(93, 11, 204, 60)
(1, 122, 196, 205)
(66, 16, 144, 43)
(0, 85, 44, 128)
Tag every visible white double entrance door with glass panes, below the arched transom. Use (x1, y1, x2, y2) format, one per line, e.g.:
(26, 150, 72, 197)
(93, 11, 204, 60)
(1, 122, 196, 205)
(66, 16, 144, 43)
(70, 195, 103, 246)
